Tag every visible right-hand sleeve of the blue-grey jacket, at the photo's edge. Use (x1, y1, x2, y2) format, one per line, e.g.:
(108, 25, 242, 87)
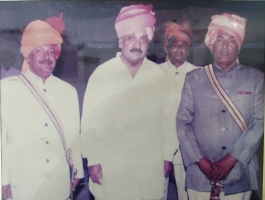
(228, 76, 264, 167)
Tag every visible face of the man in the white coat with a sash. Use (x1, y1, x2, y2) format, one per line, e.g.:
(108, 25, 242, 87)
(26, 44, 58, 80)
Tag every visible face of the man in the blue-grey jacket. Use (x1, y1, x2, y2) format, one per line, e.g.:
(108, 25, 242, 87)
(210, 31, 239, 71)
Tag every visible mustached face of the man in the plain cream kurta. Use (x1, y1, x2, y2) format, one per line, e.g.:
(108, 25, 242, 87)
(119, 30, 150, 66)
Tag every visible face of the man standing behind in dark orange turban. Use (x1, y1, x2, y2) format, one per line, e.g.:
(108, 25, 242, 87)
(165, 37, 190, 67)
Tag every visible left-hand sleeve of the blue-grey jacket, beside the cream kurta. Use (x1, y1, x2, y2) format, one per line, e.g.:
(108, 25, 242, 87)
(176, 75, 203, 166)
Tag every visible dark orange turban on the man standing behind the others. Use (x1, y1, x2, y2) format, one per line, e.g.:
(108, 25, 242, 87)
(164, 21, 192, 48)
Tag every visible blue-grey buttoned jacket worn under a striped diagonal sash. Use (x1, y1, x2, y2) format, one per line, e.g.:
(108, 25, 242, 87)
(177, 64, 264, 194)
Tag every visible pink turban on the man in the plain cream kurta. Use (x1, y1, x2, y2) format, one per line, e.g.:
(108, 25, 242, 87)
(115, 4, 156, 40)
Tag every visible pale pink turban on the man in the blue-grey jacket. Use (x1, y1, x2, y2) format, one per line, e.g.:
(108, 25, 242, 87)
(205, 13, 246, 50)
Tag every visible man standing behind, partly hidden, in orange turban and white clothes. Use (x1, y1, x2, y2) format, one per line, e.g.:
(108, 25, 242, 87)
(160, 18, 196, 200)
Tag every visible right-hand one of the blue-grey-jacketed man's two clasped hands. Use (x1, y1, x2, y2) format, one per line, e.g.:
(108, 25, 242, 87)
(211, 154, 237, 181)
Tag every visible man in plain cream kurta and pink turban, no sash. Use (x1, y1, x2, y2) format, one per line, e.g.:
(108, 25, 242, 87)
(81, 4, 175, 200)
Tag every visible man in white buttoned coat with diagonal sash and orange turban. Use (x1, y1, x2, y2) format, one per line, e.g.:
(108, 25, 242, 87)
(1, 16, 83, 200)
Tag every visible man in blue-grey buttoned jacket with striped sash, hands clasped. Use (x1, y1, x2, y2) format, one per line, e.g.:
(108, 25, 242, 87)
(177, 13, 264, 200)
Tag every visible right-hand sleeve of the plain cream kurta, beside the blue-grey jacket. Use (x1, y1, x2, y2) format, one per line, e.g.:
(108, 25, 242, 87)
(160, 77, 179, 162)
